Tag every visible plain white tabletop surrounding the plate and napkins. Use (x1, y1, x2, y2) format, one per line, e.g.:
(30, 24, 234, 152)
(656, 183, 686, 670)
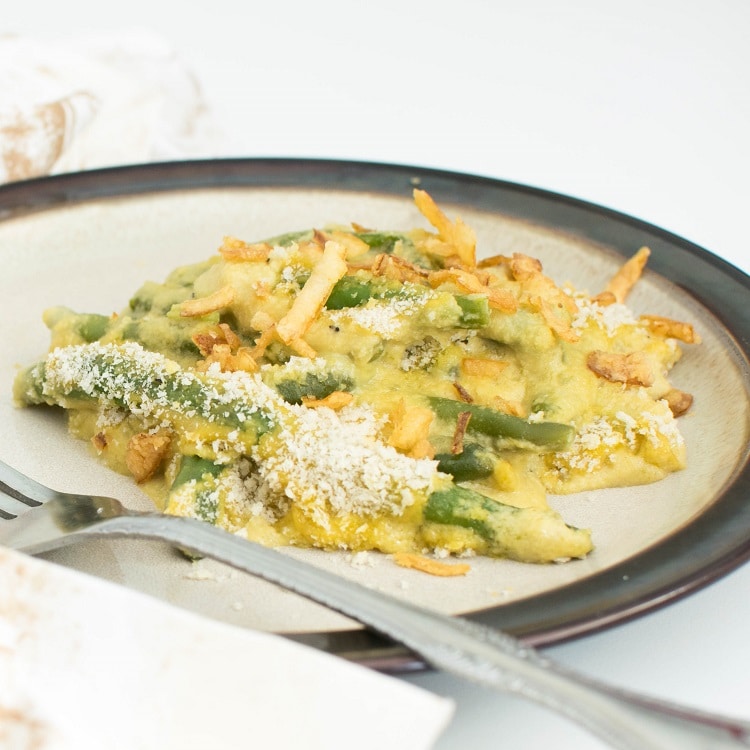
(3, 0, 750, 750)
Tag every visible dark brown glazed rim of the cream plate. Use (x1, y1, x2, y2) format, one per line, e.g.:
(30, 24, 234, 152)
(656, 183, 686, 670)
(0, 157, 750, 673)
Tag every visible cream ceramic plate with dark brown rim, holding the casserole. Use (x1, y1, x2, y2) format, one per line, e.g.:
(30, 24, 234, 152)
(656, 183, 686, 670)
(0, 159, 750, 670)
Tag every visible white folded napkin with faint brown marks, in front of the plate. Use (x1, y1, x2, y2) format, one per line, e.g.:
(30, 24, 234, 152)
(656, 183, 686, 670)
(0, 548, 453, 750)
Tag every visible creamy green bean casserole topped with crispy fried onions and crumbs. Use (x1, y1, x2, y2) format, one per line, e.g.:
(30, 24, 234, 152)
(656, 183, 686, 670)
(15, 190, 698, 575)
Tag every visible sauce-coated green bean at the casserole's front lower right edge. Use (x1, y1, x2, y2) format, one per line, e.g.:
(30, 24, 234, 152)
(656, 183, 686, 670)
(424, 486, 592, 563)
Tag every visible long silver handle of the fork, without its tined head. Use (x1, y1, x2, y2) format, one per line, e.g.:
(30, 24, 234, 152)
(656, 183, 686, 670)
(80, 514, 750, 750)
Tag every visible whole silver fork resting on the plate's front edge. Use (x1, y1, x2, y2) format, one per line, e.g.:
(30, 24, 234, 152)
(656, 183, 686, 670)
(0, 462, 750, 750)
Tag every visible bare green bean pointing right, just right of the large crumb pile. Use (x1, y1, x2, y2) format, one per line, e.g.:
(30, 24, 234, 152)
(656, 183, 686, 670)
(429, 396, 575, 451)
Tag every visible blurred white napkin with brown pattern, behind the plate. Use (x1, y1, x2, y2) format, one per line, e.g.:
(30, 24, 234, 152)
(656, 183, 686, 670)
(0, 30, 223, 183)
